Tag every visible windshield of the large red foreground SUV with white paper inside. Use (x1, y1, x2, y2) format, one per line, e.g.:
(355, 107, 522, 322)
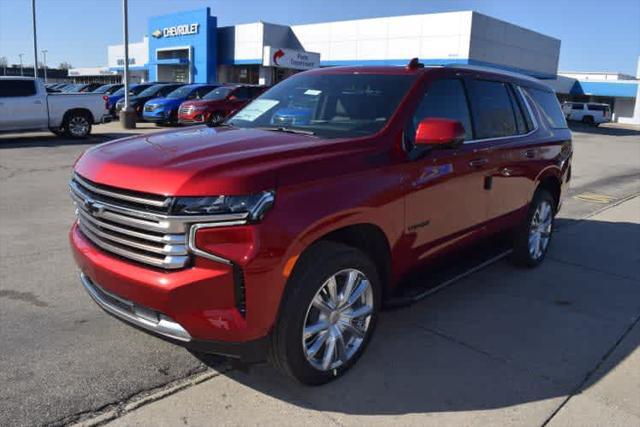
(226, 73, 415, 138)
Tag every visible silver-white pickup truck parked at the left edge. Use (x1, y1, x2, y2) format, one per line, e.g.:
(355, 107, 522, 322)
(0, 77, 111, 138)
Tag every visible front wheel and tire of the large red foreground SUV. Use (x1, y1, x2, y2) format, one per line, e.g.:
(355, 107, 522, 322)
(270, 242, 381, 385)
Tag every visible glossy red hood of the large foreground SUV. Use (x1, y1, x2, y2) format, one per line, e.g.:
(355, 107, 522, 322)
(75, 126, 369, 196)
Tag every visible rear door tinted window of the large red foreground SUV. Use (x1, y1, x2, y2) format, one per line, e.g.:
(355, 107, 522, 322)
(469, 80, 518, 139)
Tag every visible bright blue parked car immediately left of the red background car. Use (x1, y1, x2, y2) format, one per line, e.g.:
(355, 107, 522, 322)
(142, 83, 221, 125)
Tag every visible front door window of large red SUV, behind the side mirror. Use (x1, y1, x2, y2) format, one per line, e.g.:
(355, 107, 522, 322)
(407, 79, 473, 140)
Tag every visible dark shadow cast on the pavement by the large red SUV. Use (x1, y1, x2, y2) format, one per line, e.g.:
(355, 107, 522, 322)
(198, 219, 640, 416)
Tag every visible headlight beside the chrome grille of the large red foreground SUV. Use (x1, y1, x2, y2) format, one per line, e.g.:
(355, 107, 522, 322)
(172, 191, 275, 221)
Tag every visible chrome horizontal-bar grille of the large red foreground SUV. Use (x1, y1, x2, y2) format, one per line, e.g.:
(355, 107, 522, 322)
(69, 174, 189, 269)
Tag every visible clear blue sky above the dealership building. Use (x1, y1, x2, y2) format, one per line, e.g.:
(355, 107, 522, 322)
(0, 0, 640, 75)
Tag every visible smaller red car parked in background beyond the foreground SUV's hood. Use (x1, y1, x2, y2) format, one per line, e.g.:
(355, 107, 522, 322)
(178, 85, 268, 125)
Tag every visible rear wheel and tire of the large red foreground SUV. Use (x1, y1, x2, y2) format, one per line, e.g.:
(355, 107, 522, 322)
(511, 188, 556, 268)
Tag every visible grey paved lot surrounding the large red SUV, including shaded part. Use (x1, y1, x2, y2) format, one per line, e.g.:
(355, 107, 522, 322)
(0, 123, 640, 426)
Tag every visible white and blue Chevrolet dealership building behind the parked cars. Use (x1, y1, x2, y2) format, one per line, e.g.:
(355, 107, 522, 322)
(81, 8, 640, 124)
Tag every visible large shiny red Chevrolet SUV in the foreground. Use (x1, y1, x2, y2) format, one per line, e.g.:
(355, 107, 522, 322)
(70, 61, 572, 384)
